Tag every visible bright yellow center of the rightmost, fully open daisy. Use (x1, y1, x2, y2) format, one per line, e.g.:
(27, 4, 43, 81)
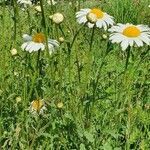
(123, 26, 141, 37)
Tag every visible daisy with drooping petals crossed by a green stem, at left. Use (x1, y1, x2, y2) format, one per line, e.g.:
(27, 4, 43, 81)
(21, 33, 59, 54)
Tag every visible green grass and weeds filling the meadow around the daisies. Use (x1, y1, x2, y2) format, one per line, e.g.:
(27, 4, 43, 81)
(0, 0, 150, 150)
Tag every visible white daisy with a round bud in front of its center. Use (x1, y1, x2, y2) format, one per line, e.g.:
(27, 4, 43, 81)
(76, 8, 114, 30)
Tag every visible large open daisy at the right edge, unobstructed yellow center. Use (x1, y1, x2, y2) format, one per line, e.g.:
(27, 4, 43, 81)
(108, 23, 150, 50)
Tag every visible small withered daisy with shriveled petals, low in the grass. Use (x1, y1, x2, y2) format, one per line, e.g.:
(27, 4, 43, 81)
(30, 99, 46, 114)
